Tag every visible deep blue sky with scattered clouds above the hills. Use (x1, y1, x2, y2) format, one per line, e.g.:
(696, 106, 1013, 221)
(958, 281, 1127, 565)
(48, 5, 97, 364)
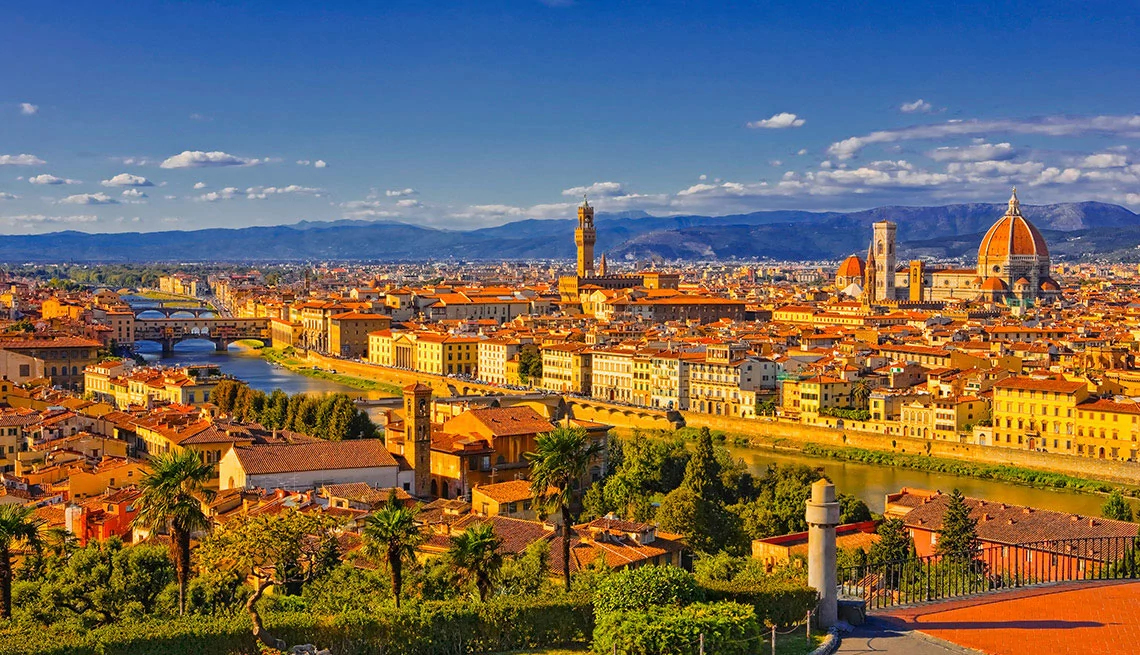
(0, 0, 1140, 234)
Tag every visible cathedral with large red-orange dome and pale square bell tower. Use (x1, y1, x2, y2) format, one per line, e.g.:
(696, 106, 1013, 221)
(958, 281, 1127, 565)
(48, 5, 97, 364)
(836, 189, 1060, 306)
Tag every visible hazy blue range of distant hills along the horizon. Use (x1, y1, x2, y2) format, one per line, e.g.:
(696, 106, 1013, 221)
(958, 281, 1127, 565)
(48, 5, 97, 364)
(0, 203, 1140, 263)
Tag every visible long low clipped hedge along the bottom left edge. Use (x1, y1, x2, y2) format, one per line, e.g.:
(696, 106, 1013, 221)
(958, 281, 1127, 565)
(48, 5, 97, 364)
(0, 595, 594, 655)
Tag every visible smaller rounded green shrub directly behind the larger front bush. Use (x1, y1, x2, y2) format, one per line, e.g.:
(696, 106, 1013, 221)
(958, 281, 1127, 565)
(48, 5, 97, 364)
(594, 566, 701, 619)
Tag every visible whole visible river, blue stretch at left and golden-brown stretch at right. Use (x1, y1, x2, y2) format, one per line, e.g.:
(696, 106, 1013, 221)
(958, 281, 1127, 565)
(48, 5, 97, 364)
(138, 342, 1121, 524)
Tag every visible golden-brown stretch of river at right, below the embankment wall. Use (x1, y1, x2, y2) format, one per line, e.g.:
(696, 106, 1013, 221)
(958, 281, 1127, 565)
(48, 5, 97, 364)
(728, 447, 1126, 516)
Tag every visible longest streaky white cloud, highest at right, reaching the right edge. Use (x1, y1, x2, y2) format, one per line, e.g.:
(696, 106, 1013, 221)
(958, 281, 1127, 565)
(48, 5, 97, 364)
(828, 114, 1140, 159)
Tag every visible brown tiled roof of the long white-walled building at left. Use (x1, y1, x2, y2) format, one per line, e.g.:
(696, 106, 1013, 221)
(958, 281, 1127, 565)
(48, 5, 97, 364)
(234, 439, 397, 475)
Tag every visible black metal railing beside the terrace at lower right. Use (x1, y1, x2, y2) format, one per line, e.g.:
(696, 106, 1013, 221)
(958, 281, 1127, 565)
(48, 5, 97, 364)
(837, 537, 1140, 611)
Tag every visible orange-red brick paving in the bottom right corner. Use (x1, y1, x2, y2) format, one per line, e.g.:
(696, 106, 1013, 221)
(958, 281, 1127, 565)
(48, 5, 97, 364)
(879, 581, 1140, 655)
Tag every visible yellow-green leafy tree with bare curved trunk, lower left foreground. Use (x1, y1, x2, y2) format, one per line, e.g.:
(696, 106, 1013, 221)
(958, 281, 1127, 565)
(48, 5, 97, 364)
(197, 508, 339, 649)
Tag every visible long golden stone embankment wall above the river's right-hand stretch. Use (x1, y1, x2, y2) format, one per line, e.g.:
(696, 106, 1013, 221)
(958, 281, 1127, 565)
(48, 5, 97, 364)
(682, 412, 1140, 485)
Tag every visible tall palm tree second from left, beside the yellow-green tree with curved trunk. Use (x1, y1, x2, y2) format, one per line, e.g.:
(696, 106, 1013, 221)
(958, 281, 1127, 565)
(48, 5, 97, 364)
(135, 450, 214, 614)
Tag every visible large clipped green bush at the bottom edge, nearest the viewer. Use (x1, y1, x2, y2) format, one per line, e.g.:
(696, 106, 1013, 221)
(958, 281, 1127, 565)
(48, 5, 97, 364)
(594, 603, 760, 655)
